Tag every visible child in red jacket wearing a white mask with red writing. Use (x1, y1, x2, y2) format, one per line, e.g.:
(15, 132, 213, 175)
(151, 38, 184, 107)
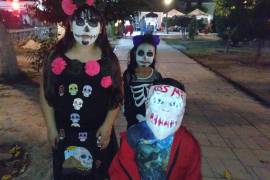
(109, 78, 202, 180)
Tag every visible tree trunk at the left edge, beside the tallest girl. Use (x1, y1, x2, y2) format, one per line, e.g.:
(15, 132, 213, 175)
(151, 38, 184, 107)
(0, 23, 20, 80)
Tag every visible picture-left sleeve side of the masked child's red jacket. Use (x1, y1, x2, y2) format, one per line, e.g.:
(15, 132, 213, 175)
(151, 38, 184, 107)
(109, 134, 140, 180)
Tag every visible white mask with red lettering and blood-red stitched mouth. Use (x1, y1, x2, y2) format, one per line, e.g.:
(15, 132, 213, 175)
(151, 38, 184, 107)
(146, 85, 186, 140)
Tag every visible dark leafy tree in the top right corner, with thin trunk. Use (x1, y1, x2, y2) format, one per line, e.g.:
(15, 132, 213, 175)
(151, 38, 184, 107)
(215, 0, 270, 59)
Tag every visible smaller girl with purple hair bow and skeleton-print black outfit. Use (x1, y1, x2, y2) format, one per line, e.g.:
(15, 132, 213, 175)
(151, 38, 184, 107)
(123, 34, 162, 128)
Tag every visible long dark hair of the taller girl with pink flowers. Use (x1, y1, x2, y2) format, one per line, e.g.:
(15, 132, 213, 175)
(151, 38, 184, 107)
(43, 5, 122, 108)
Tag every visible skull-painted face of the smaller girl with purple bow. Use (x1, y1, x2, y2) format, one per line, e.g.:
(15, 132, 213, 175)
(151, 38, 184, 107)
(136, 43, 156, 67)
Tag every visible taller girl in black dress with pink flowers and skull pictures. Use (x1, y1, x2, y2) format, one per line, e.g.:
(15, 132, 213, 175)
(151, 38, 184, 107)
(41, 0, 122, 180)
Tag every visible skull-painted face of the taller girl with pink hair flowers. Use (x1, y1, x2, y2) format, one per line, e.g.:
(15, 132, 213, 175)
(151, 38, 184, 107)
(71, 12, 101, 46)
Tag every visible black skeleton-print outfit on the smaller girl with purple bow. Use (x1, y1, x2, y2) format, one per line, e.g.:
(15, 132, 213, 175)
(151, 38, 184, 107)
(123, 70, 162, 128)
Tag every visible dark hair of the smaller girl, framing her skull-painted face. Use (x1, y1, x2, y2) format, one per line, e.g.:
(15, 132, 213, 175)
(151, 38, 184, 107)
(127, 34, 157, 74)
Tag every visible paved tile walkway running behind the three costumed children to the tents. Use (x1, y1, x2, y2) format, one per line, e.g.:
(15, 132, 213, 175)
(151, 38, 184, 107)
(115, 39, 270, 180)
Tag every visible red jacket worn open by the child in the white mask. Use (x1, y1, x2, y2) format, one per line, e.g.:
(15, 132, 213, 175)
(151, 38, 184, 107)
(109, 127, 202, 180)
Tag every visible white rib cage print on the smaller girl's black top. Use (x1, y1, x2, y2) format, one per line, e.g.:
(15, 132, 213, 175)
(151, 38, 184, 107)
(130, 84, 151, 107)
